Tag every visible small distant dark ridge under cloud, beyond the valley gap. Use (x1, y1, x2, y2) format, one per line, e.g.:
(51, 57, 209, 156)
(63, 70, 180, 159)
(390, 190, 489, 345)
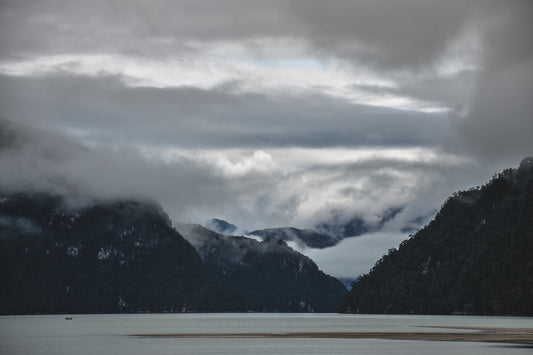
(250, 227, 338, 249)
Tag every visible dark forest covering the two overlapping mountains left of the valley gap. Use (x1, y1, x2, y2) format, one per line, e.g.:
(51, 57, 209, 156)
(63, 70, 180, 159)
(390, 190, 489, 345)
(0, 193, 346, 314)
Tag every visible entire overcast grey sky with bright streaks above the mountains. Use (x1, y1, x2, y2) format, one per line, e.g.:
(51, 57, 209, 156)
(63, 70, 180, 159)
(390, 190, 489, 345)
(0, 0, 533, 275)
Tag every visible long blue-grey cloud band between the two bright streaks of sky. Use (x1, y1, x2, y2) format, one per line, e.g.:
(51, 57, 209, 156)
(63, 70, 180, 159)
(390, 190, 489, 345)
(0, 76, 450, 148)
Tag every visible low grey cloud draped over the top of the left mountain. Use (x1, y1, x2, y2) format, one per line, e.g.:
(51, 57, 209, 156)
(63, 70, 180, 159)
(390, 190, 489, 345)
(0, 120, 266, 224)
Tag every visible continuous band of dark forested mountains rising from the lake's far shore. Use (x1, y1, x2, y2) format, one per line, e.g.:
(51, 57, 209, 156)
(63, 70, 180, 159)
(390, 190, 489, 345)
(0, 158, 533, 315)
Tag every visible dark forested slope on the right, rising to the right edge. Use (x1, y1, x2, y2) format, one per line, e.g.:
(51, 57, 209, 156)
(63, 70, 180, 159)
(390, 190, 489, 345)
(341, 158, 533, 316)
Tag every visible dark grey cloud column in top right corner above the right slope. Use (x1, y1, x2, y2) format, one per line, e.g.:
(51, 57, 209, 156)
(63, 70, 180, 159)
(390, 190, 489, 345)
(456, 0, 533, 156)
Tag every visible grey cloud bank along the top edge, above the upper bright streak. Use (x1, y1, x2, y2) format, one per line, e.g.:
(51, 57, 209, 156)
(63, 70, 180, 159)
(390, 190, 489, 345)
(0, 0, 478, 69)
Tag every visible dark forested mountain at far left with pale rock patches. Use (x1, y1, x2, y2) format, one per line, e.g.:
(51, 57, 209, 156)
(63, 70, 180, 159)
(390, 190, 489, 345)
(0, 193, 247, 314)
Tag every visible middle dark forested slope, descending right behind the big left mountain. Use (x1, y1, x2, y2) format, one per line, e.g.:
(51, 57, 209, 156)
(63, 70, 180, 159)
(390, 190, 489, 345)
(177, 225, 346, 312)
